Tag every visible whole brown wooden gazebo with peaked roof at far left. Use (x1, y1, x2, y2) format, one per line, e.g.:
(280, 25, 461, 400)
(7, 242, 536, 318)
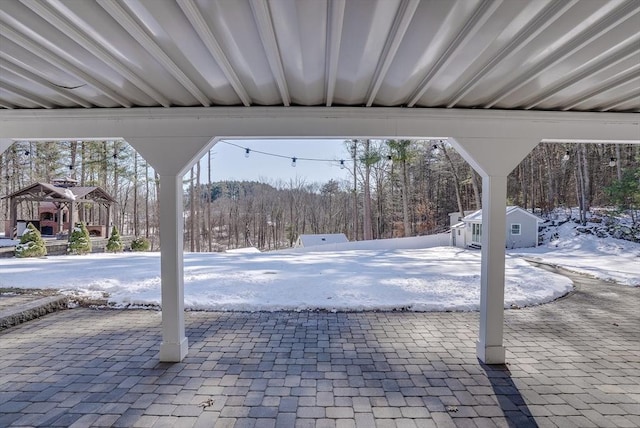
(2, 178, 116, 238)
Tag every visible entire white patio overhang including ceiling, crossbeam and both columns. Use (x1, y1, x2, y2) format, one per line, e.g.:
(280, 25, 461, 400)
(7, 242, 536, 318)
(0, 0, 640, 363)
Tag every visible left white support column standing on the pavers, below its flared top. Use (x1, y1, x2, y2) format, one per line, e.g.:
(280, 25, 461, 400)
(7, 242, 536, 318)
(159, 175, 188, 362)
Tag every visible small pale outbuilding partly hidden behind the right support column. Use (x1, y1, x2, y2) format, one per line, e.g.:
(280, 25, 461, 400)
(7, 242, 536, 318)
(451, 206, 543, 248)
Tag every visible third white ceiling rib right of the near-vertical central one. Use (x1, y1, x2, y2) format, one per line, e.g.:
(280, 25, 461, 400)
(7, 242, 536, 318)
(447, 0, 579, 108)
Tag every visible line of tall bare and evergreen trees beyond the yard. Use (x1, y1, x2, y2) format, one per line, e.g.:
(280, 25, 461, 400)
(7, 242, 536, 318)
(0, 139, 640, 251)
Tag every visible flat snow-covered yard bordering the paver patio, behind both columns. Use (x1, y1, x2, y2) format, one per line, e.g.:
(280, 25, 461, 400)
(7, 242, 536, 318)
(0, 247, 572, 311)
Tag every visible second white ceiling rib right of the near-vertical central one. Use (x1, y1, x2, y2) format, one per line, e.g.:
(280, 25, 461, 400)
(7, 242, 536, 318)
(407, 0, 502, 107)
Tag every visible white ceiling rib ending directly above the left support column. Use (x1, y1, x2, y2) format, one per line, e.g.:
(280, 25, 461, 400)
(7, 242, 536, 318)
(20, 0, 171, 107)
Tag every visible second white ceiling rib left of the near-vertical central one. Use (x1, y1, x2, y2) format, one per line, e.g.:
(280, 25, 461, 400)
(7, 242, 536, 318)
(178, 0, 251, 107)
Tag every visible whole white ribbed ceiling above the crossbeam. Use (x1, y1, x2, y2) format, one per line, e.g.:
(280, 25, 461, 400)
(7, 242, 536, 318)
(0, 0, 640, 112)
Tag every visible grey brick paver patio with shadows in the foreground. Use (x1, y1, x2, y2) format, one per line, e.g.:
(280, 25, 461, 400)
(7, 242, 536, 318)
(0, 268, 640, 428)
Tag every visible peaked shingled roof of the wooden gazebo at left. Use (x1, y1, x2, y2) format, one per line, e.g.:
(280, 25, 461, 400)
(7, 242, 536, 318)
(2, 182, 116, 203)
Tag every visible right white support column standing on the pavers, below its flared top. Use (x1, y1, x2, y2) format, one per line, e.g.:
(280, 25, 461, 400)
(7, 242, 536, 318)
(476, 176, 507, 364)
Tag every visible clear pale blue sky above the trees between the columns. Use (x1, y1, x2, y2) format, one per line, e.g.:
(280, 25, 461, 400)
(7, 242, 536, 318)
(201, 140, 352, 183)
